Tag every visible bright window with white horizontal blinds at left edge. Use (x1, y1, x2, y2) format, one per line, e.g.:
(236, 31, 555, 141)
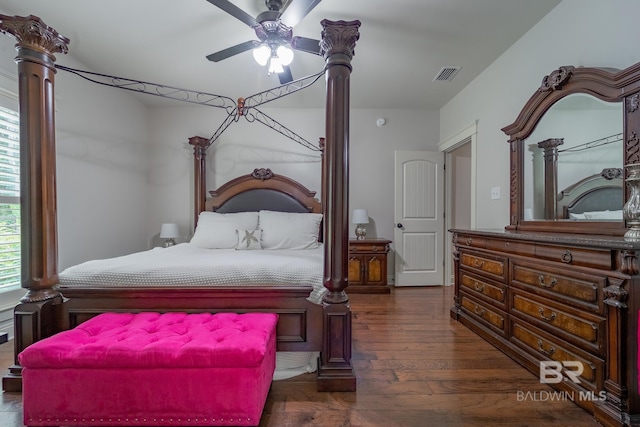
(0, 107, 21, 291)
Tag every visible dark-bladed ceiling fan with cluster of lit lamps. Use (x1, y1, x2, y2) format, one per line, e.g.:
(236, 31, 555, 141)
(207, 0, 321, 84)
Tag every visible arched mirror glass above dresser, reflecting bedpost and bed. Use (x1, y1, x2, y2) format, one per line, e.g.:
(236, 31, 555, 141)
(524, 94, 624, 221)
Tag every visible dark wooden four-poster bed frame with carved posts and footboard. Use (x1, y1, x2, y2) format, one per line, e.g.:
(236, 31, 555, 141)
(0, 15, 360, 391)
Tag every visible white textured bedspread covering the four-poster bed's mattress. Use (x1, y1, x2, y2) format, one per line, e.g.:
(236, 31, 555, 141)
(59, 243, 326, 304)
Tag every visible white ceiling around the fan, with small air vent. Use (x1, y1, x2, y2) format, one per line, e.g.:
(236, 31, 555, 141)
(0, 0, 561, 109)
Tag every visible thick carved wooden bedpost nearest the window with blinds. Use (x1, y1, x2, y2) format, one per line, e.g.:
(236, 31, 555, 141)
(0, 15, 69, 391)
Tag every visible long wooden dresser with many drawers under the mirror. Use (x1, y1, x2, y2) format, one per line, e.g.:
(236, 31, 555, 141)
(451, 230, 640, 425)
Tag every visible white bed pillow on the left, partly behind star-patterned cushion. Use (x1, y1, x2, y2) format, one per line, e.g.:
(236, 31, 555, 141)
(190, 212, 258, 249)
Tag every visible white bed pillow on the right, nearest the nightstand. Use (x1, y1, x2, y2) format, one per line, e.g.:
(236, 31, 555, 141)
(259, 211, 322, 249)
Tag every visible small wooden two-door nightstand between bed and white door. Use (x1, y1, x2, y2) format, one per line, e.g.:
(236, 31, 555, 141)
(347, 239, 391, 294)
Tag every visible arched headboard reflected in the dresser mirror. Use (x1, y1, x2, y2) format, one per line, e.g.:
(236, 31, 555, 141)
(558, 168, 624, 219)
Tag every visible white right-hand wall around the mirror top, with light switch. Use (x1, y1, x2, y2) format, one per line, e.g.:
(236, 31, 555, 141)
(440, 0, 640, 228)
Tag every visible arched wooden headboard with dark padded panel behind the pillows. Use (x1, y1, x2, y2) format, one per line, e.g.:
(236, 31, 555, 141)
(205, 168, 322, 213)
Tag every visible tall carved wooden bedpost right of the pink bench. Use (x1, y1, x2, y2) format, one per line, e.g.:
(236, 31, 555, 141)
(318, 19, 360, 391)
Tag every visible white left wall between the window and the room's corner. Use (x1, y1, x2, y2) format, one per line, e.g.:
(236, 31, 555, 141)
(0, 30, 149, 270)
